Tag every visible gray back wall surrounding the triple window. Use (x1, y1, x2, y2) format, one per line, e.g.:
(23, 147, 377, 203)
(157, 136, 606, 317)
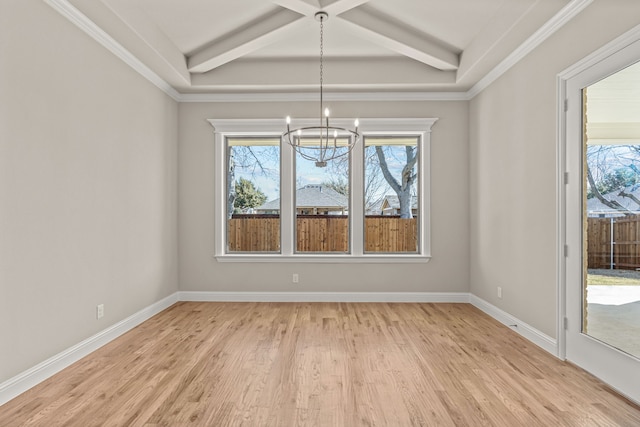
(178, 102, 469, 292)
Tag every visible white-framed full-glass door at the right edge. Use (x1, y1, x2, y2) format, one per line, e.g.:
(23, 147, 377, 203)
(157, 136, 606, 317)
(565, 52, 640, 401)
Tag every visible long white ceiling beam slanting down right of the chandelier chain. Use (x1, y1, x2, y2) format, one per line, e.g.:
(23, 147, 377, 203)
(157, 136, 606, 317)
(339, 6, 460, 71)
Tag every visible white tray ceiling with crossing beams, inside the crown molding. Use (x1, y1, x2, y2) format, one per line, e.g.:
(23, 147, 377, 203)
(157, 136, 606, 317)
(62, 0, 576, 94)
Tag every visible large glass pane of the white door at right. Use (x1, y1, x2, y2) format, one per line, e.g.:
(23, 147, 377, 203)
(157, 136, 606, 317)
(582, 60, 640, 358)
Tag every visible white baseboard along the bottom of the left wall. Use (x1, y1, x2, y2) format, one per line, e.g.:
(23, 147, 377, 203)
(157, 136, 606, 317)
(0, 293, 178, 405)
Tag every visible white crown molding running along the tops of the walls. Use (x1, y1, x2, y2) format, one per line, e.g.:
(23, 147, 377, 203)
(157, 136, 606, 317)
(44, 0, 593, 102)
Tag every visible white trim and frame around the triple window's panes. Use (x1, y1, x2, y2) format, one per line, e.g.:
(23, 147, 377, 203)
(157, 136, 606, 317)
(207, 118, 438, 263)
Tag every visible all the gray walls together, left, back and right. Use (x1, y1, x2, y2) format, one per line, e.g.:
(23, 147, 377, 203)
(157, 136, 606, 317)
(5, 0, 640, 392)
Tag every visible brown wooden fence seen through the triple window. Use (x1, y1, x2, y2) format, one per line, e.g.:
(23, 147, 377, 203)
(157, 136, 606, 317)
(227, 215, 418, 253)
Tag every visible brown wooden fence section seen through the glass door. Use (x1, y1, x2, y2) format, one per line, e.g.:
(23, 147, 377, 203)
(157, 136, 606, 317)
(587, 215, 640, 270)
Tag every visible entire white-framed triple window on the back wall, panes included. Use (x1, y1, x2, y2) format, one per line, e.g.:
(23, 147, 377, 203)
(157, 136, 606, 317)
(209, 119, 437, 262)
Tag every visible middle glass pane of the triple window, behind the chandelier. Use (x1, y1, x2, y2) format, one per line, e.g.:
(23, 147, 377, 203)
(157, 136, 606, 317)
(295, 137, 350, 253)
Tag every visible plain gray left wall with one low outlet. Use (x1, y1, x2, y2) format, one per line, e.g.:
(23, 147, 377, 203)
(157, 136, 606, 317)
(0, 0, 178, 383)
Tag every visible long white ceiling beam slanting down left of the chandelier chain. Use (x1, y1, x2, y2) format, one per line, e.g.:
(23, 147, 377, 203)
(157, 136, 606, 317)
(188, 9, 308, 73)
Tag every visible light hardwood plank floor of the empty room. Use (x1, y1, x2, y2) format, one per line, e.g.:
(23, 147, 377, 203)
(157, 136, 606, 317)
(0, 303, 640, 427)
